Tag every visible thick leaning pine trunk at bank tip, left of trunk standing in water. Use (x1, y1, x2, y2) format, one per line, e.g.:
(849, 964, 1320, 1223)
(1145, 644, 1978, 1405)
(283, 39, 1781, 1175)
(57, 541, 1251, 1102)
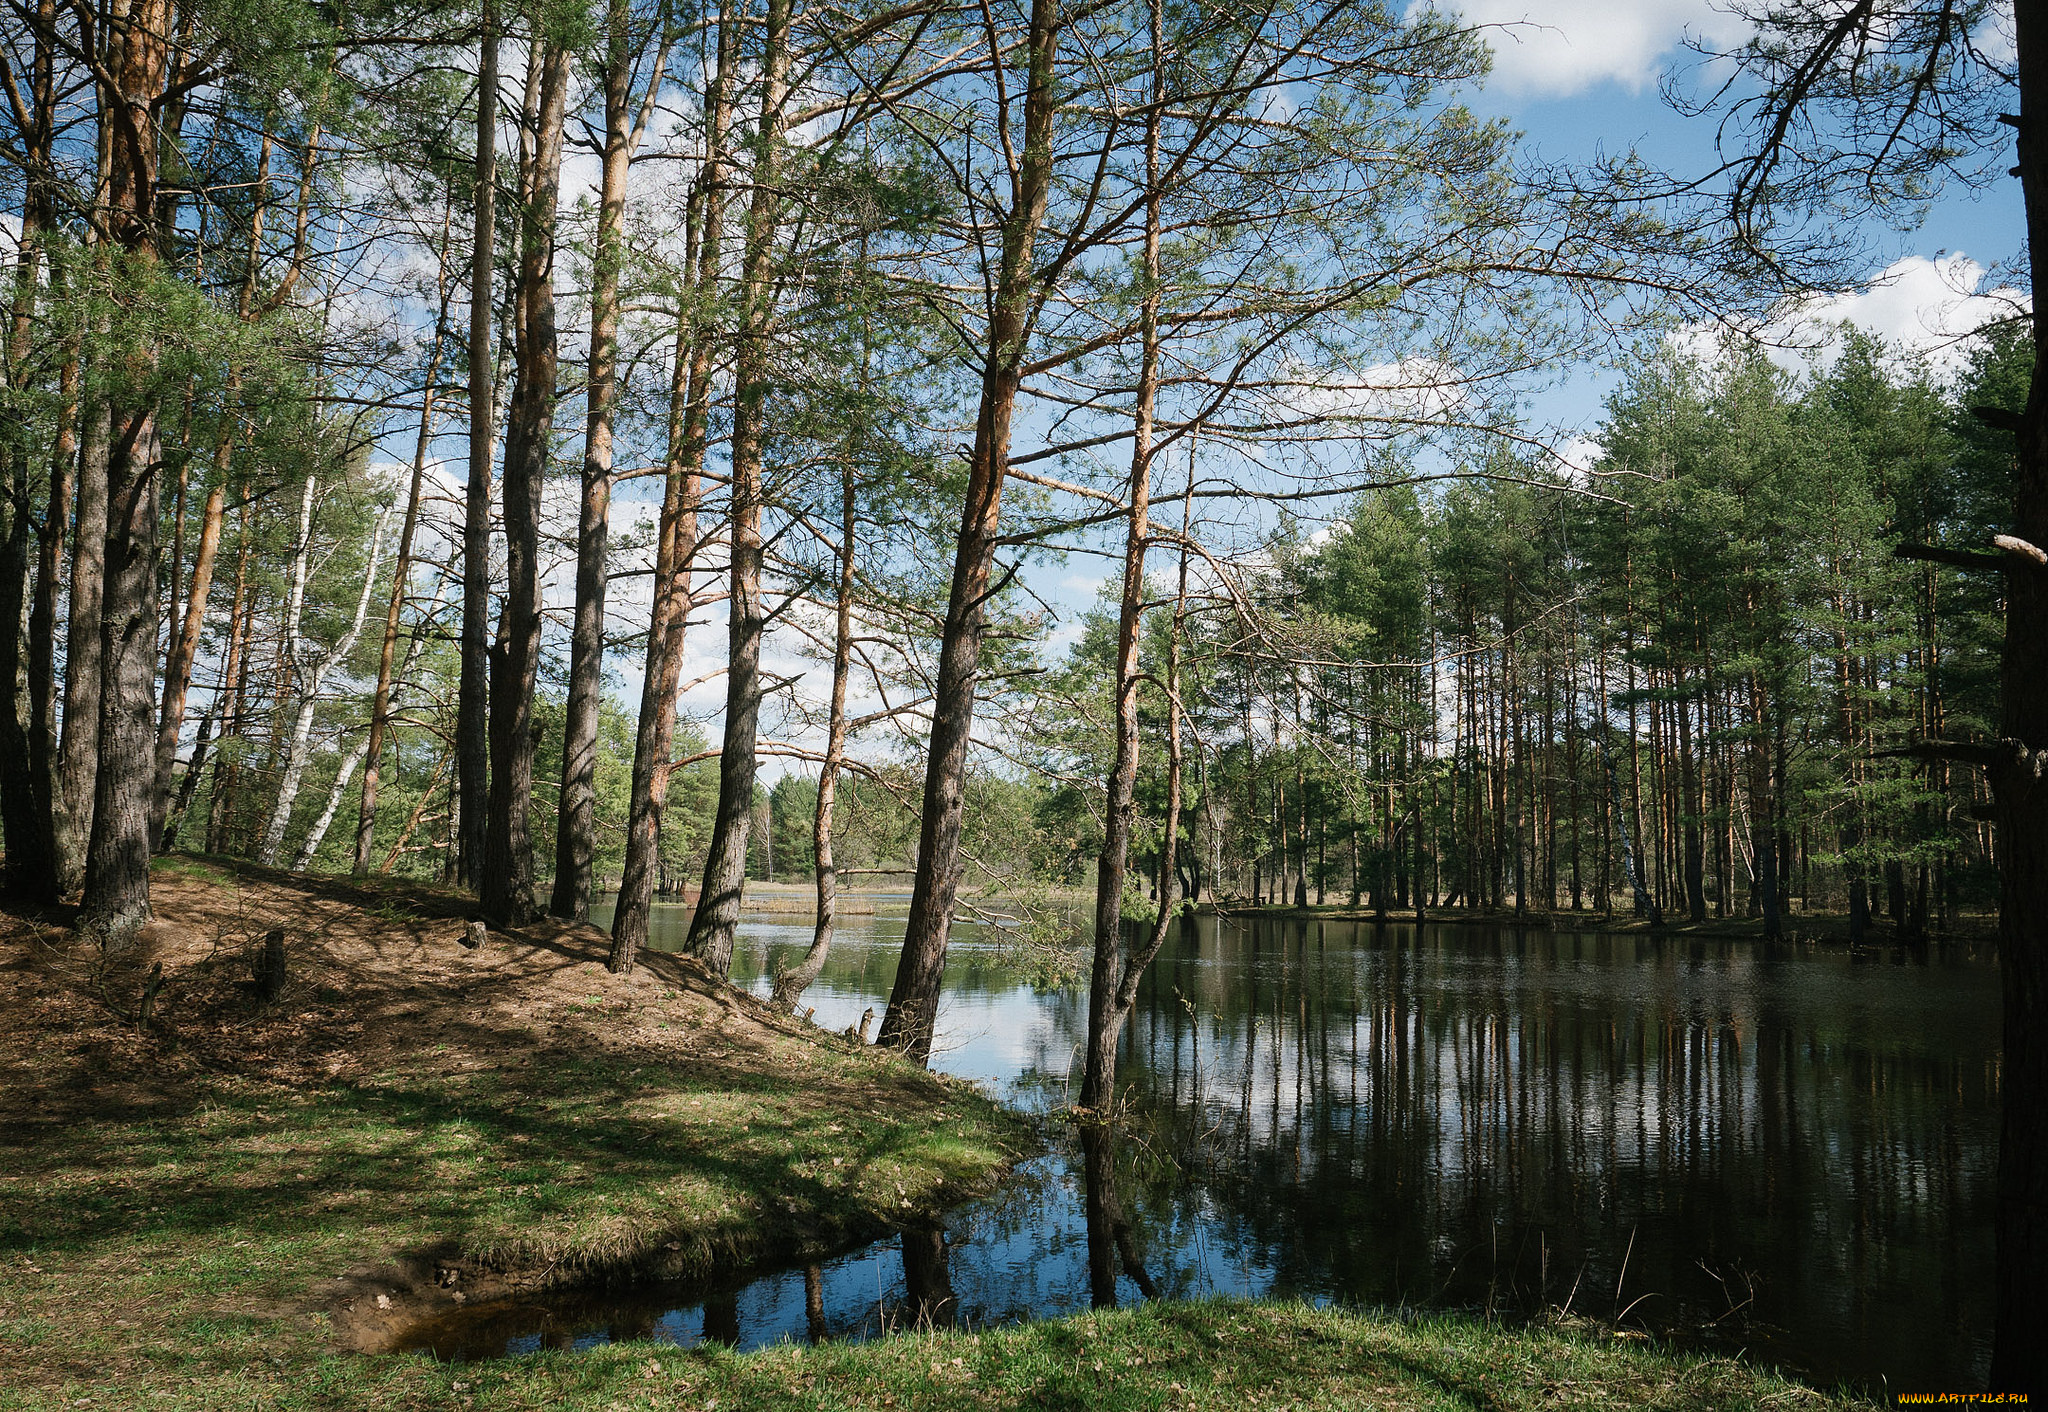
(879, 0, 1061, 1064)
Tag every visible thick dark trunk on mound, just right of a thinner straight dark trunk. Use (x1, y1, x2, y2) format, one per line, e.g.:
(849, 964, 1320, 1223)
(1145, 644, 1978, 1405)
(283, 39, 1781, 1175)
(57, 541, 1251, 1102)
(477, 30, 569, 926)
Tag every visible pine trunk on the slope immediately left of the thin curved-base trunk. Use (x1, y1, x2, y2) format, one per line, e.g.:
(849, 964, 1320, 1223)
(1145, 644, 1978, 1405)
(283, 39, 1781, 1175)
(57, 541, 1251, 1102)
(688, 0, 791, 975)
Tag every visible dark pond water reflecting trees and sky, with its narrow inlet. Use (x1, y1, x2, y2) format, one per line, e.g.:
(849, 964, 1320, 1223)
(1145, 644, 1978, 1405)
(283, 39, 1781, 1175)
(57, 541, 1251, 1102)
(399, 898, 1999, 1387)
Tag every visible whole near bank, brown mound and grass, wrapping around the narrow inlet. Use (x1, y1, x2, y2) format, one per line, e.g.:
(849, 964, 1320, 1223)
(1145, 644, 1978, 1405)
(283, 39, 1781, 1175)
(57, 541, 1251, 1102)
(0, 859, 1855, 1412)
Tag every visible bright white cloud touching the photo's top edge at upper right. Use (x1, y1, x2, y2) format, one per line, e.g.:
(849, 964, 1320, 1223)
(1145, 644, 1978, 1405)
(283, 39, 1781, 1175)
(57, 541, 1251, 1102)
(1456, 0, 1729, 98)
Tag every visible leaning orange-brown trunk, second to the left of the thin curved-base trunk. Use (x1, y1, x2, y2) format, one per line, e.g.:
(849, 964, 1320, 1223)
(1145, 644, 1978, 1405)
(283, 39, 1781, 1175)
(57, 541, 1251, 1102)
(606, 0, 739, 975)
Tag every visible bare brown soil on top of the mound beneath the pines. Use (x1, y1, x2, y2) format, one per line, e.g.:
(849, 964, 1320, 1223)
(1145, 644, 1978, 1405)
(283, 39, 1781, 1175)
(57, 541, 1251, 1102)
(0, 859, 831, 1129)
